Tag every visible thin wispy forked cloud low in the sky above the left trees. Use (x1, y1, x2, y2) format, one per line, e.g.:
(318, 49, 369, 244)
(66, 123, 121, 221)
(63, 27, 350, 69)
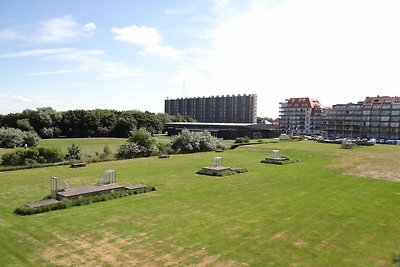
(0, 48, 141, 78)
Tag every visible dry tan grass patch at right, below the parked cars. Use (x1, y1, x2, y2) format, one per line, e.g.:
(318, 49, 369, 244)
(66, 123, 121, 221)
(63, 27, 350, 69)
(331, 151, 400, 182)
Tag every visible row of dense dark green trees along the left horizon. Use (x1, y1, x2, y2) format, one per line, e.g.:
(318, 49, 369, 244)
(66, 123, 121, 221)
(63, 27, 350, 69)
(0, 107, 194, 138)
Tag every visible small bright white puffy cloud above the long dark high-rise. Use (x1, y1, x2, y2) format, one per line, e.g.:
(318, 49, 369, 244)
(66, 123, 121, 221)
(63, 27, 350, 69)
(111, 25, 182, 58)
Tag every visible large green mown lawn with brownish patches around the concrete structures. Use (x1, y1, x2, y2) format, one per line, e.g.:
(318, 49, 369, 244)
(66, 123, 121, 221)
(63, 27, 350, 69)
(0, 141, 400, 266)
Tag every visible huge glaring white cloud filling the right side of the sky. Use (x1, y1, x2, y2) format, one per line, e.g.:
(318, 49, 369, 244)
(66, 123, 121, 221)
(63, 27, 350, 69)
(171, 0, 400, 116)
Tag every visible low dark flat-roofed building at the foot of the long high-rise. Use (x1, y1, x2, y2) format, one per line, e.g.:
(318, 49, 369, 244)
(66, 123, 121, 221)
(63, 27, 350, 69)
(166, 122, 282, 139)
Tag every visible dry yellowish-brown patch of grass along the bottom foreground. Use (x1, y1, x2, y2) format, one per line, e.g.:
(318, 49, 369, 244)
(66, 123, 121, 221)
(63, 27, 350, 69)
(41, 232, 247, 267)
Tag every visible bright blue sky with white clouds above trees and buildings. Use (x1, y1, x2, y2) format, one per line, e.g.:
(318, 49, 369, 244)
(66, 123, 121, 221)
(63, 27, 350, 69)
(0, 0, 400, 118)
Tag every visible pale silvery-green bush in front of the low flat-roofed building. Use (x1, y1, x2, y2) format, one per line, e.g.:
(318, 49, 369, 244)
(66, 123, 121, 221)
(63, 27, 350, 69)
(171, 130, 225, 153)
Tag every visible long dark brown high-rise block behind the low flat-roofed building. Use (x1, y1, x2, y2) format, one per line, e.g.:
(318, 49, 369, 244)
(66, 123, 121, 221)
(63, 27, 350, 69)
(165, 94, 257, 123)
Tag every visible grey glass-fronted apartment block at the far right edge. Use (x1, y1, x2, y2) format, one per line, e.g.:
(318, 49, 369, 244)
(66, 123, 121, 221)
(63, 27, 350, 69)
(322, 96, 400, 139)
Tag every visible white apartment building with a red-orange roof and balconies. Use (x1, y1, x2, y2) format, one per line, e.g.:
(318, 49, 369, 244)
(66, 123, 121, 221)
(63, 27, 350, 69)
(279, 97, 324, 135)
